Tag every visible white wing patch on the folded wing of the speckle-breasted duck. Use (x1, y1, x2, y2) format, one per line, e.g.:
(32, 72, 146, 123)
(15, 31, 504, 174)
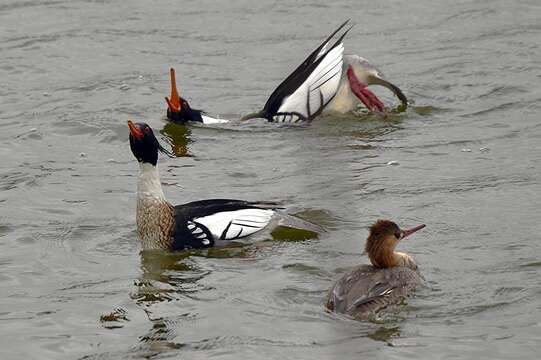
(194, 209, 274, 240)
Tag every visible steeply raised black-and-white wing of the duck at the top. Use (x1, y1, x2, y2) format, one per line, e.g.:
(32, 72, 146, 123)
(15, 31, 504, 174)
(260, 20, 351, 122)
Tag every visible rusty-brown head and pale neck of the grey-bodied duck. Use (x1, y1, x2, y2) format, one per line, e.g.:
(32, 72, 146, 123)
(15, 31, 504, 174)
(365, 220, 426, 270)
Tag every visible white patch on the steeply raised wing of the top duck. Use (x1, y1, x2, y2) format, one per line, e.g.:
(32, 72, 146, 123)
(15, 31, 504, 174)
(275, 44, 344, 122)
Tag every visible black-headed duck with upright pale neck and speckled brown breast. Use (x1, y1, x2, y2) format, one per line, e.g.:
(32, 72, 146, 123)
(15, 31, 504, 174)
(128, 121, 322, 251)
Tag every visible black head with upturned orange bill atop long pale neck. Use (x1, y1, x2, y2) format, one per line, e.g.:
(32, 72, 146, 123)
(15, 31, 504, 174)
(128, 120, 169, 166)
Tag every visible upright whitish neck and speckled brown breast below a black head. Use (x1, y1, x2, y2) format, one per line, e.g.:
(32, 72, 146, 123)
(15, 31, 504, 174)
(137, 163, 175, 250)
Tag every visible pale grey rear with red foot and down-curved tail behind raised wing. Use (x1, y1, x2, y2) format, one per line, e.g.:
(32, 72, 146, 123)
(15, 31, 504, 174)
(325, 55, 408, 114)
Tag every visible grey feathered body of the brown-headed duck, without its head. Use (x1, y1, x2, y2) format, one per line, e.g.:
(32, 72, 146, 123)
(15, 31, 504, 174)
(327, 265, 423, 320)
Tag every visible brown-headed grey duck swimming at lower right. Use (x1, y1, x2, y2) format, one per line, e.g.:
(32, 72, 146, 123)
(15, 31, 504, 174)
(327, 220, 425, 320)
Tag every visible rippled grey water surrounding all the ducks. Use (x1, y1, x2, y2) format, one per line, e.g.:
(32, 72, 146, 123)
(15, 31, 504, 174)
(0, 0, 541, 359)
